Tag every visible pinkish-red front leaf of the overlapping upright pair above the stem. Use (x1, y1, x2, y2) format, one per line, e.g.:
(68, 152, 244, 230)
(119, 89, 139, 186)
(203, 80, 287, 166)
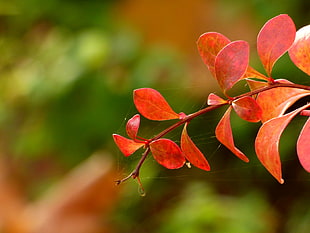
(214, 40, 250, 92)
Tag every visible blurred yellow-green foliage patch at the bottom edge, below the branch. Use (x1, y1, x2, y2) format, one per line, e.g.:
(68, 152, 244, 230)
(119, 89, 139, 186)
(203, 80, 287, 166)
(159, 182, 275, 233)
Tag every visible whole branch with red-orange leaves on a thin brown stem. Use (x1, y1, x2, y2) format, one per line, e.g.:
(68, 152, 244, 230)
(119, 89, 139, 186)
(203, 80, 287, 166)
(113, 14, 310, 188)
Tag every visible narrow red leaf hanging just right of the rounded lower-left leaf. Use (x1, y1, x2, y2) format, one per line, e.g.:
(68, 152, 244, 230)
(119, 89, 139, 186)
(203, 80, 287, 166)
(181, 123, 210, 171)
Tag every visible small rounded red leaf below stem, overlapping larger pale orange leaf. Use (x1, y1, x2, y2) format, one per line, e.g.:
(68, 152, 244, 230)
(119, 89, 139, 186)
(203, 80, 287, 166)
(232, 96, 262, 122)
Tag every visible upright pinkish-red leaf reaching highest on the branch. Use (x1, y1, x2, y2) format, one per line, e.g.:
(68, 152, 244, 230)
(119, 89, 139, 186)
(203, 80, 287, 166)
(257, 14, 296, 77)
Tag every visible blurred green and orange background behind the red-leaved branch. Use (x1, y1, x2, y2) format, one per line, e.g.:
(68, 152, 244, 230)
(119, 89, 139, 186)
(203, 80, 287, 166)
(0, 0, 310, 233)
